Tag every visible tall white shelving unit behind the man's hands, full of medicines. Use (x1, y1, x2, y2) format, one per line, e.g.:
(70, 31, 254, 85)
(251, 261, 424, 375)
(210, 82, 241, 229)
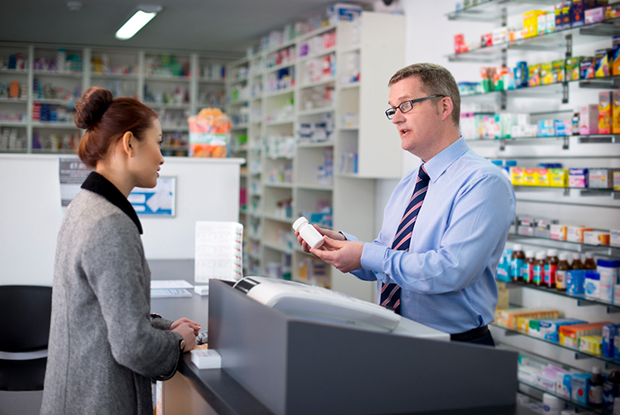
(227, 12, 404, 301)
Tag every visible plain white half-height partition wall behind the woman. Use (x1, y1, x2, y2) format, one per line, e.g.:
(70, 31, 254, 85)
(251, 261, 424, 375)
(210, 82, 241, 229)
(0, 154, 243, 285)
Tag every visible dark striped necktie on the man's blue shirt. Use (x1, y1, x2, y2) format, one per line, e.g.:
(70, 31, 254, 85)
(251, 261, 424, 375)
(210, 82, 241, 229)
(380, 165, 430, 314)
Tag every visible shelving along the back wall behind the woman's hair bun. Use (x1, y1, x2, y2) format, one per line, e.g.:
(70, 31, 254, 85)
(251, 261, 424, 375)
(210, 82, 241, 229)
(0, 43, 231, 156)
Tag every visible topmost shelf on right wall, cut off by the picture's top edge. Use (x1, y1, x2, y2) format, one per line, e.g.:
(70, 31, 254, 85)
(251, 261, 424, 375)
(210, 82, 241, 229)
(445, 0, 557, 22)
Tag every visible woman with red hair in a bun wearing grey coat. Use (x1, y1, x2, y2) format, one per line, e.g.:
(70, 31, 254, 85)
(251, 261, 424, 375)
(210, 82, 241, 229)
(41, 87, 200, 415)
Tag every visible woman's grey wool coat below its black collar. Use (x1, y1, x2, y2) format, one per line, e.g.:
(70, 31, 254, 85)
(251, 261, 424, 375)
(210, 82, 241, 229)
(41, 176, 182, 415)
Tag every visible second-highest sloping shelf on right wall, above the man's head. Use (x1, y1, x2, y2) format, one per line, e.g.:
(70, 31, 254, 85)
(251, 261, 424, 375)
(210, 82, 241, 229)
(445, 17, 620, 63)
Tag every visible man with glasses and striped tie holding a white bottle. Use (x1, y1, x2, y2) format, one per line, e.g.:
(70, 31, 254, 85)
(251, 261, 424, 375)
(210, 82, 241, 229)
(298, 63, 515, 346)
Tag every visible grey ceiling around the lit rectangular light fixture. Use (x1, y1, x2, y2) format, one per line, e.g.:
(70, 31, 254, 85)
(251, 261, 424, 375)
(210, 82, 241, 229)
(0, 0, 373, 57)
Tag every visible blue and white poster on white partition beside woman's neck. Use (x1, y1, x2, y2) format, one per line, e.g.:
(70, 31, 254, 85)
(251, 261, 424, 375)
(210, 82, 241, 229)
(128, 176, 176, 218)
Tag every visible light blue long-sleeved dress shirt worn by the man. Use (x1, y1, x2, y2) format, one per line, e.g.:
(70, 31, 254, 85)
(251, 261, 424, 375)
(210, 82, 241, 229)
(344, 138, 515, 334)
